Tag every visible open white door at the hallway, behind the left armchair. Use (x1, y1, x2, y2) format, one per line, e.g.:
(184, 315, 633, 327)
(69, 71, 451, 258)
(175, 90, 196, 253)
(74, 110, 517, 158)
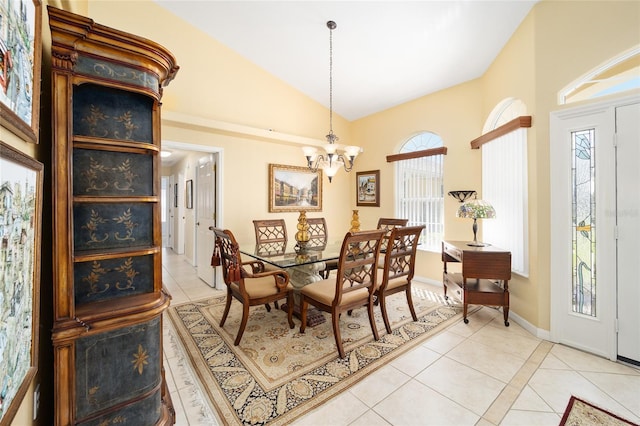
(194, 154, 216, 287)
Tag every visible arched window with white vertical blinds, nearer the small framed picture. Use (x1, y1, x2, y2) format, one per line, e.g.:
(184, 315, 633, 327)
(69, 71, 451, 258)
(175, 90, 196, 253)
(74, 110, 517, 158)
(388, 132, 446, 251)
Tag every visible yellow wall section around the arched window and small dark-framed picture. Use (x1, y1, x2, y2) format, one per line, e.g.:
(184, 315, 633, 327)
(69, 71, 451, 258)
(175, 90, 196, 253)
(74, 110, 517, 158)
(353, 80, 483, 281)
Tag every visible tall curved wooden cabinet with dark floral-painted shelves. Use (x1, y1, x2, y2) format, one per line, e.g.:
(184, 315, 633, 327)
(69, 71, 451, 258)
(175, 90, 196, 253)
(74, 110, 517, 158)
(48, 7, 178, 426)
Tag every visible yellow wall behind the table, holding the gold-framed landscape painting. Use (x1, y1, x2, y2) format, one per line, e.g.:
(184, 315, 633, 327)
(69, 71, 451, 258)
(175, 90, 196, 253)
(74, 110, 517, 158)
(89, 1, 356, 241)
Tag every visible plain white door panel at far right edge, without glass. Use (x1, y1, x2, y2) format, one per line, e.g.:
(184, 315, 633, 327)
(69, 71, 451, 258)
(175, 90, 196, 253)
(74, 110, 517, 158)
(616, 103, 640, 365)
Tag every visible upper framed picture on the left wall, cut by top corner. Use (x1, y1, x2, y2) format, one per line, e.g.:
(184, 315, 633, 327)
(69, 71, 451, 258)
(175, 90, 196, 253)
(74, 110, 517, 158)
(0, 0, 42, 143)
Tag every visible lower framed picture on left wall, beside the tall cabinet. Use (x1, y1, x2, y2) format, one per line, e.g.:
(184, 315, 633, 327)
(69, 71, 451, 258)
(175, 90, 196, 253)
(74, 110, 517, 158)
(0, 142, 43, 424)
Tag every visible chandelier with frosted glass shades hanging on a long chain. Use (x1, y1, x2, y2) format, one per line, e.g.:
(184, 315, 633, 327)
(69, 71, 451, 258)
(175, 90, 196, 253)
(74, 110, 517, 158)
(302, 21, 362, 182)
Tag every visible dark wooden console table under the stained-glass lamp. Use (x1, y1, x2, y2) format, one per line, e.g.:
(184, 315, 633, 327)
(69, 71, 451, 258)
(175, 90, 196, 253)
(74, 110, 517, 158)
(442, 241, 511, 327)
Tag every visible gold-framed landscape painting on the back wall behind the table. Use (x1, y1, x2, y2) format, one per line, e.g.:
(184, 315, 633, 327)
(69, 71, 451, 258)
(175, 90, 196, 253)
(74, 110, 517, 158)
(269, 164, 322, 212)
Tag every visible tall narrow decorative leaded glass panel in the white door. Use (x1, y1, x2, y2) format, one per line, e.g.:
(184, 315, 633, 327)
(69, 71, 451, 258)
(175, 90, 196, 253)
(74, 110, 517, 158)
(571, 129, 596, 317)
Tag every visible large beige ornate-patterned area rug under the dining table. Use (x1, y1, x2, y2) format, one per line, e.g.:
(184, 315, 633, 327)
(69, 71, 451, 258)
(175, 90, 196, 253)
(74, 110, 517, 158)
(168, 286, 462, 425)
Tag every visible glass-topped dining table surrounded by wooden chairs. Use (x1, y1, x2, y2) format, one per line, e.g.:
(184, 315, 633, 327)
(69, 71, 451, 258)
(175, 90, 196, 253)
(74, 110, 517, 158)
(239, 240, 342, 327)
